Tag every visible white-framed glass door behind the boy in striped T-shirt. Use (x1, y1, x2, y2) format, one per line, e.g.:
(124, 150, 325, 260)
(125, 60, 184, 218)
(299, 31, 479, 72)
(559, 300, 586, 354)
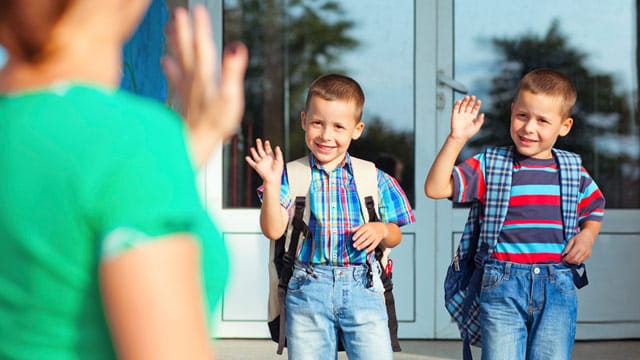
(436, 0, 640, 339)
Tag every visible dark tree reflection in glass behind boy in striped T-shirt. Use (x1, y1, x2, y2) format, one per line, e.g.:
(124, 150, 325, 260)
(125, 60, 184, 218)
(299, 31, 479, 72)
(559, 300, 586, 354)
(478, 21, 640, 208)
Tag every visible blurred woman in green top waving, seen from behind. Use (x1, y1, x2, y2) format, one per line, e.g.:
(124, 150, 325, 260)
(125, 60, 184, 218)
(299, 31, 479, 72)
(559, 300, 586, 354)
(0, 0, 247, 359)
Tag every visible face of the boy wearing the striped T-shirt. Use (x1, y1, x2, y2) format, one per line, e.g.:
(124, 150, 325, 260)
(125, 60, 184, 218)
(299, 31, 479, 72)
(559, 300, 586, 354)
(510, 90, 573, 159)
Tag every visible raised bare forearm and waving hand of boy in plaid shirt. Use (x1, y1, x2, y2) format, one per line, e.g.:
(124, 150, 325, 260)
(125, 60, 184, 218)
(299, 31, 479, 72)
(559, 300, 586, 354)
(245, 139, 289, 240)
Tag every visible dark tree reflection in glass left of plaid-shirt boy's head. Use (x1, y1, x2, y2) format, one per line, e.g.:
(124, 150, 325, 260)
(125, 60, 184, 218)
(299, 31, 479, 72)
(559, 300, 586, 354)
(224, 0, 357, 207)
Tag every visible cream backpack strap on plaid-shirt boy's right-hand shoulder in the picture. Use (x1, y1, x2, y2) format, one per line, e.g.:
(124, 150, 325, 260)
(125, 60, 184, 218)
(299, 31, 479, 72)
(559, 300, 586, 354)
(351, 156, 380, 222)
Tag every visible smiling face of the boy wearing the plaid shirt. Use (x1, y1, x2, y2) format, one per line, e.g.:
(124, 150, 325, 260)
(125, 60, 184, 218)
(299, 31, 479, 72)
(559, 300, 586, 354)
(300, 96, 364, 170)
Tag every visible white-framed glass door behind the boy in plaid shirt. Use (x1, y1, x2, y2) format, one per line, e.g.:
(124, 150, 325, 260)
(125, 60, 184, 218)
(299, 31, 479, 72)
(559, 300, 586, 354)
(200, 0, 435, 338)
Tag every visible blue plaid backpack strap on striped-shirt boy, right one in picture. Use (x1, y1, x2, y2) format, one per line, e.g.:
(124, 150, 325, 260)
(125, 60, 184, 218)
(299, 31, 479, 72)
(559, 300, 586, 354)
(553, 149, 582, 240)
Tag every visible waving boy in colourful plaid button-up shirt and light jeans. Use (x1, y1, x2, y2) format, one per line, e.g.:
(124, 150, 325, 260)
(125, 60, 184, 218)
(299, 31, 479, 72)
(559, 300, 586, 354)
(246, 74, 414, 360)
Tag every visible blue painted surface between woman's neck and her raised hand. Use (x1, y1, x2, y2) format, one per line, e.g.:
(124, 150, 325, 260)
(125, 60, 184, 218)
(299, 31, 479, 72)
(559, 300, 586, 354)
(120, 0, 168, 102)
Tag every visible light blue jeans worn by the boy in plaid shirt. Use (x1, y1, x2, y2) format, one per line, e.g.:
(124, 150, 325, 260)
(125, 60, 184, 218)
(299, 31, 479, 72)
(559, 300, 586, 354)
(286, 263, 393, 360)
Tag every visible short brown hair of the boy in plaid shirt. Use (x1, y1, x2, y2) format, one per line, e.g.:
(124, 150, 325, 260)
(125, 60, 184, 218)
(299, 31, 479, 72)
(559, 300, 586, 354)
(304, 74, 364, 122)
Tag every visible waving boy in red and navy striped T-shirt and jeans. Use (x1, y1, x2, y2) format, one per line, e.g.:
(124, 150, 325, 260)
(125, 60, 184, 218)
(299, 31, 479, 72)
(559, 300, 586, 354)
(425, 69, 605, 360)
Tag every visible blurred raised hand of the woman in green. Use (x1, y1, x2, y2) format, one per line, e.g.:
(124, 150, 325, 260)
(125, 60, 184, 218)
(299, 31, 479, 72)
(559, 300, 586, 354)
(162, 5, 248, 165)
